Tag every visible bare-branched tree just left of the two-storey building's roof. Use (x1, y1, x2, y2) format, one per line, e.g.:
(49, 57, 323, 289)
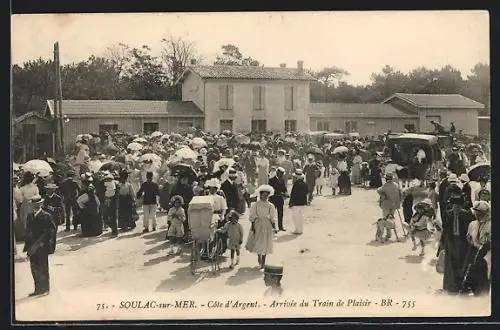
(161, 37, 203, 99)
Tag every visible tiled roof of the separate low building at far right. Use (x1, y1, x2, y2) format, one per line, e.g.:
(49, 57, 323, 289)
(383, 93, 484, 109)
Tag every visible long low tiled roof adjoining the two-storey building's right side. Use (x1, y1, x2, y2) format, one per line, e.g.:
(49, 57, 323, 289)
(309, 103, 418, 118)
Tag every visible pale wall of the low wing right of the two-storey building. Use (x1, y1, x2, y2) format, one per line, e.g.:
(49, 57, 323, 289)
(310, 115, 419, 136)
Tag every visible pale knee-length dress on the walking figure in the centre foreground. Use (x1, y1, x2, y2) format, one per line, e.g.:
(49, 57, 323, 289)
(248, 200, 278, 255)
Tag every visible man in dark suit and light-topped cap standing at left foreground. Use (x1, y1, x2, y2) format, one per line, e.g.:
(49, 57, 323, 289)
(23, 195, 57, 296)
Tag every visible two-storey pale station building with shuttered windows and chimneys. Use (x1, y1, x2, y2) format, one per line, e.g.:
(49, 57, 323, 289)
(179, 61, 314, 133)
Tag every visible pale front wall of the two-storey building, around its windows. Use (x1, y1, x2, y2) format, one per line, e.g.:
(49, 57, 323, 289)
(205, 79, 309, 133)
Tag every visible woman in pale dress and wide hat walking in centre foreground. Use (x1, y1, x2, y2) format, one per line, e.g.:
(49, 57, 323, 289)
(246, 185, 278, 271)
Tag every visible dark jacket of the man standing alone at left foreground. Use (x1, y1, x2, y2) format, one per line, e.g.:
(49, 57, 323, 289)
(23, 210, 56, 254)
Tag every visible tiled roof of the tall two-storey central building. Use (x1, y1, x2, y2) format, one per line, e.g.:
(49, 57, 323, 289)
(184, 65, 316, 80)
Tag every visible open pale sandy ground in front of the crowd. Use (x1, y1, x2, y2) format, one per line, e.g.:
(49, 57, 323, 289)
(14, 188, 490, 320)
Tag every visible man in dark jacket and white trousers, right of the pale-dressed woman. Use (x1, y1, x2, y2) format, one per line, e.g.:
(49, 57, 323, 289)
(288, 169, 309, 235)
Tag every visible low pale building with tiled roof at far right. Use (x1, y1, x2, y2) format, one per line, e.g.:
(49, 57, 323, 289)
(383, 93, 484, 135)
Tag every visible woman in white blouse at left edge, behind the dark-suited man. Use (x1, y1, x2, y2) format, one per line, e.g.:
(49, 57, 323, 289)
(15, 172, 39, 241)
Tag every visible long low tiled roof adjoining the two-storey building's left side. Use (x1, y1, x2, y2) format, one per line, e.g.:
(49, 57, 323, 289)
(47, 100, 203, 117)
